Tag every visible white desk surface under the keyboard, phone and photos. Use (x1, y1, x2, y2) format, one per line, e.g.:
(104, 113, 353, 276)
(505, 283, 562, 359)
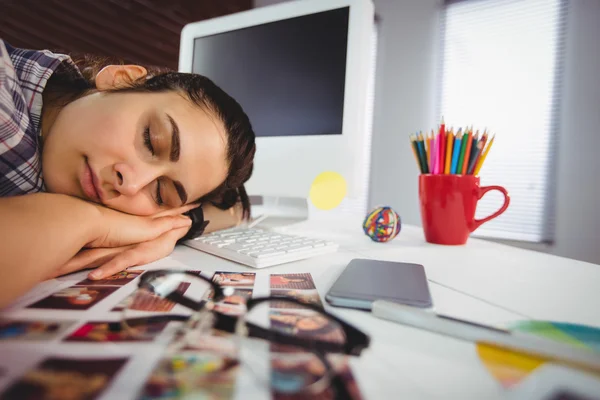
(0, 220, 600, 399)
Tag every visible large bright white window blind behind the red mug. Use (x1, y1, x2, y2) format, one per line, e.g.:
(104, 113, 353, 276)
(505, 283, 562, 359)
(439, 0, 566, 242)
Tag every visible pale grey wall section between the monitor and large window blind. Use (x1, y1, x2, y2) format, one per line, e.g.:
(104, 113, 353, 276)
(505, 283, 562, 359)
(360, 0, 442, 225)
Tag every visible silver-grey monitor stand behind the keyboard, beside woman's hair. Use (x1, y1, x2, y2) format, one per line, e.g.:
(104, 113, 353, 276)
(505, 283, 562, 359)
(250, 196, 309, 229)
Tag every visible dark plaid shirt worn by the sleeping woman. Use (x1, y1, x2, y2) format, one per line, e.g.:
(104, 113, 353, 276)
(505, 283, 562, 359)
(0, 39, 78, 197)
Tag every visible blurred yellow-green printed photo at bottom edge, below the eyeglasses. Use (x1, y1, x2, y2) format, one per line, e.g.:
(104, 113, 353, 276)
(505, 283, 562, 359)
(138, 352, 239, 400)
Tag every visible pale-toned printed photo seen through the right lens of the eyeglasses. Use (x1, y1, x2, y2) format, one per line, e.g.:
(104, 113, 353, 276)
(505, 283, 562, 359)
(269, 310, 346, 343)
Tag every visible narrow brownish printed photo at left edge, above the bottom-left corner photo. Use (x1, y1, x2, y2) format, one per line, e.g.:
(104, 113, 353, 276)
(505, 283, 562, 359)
(0, 319, 76, 340)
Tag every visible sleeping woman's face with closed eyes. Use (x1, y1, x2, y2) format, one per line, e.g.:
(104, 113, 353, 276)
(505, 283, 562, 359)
(42, 88, 227, 215)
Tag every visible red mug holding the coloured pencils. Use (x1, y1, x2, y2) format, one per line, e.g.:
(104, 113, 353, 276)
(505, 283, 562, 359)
(419, 174, 510, 244)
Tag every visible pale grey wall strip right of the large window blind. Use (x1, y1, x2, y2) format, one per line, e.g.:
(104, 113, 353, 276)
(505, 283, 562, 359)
(551, 0, 600, 264)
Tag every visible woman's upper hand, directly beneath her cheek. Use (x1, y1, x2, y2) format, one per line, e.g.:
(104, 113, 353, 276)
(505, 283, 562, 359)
(84, 204, 199, 248)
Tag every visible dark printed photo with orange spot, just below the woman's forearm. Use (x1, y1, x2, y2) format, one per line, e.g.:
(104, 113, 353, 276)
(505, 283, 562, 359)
(27, 286, 119, 310)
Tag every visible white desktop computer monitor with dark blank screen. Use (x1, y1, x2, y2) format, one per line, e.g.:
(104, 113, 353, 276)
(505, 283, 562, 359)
(179, 0, 374, 209)
